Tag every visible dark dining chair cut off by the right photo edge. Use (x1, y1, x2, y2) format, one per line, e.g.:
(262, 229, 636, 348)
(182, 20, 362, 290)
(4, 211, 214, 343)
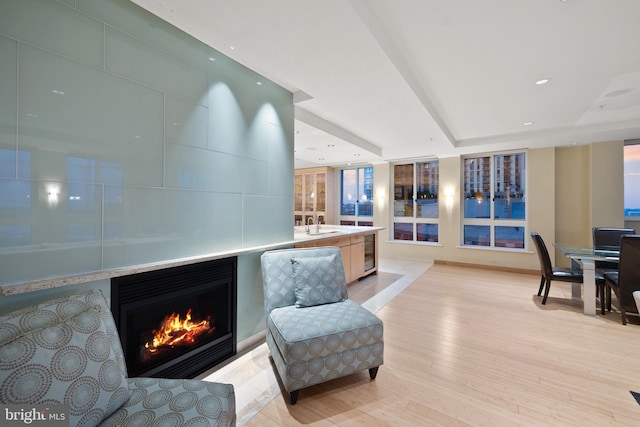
(604, 235, 640, 325)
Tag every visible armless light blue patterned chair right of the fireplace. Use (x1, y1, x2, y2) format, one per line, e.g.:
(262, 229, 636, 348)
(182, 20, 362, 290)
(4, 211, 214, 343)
(261, 247, 384, 405)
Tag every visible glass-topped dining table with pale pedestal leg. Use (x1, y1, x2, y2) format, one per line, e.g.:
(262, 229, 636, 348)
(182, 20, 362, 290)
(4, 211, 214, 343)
(553, 243, 620, 316)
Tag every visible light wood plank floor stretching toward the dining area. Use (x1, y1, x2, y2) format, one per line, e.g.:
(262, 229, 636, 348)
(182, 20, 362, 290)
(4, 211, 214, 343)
(245, 265, 640, 427)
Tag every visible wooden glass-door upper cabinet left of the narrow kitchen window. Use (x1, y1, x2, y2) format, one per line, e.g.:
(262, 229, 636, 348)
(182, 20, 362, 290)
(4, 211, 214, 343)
(293, 167, 335, 225)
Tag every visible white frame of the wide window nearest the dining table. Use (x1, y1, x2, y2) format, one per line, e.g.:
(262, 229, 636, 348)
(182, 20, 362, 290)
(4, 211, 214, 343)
(460, 149, 530, 252)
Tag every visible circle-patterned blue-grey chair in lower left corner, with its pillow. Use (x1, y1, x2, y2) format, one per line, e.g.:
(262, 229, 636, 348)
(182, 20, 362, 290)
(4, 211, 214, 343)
(0, 289, 236, 427)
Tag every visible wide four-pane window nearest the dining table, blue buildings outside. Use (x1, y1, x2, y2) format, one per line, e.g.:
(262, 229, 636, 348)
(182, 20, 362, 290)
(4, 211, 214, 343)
(462, 153, 526, 249)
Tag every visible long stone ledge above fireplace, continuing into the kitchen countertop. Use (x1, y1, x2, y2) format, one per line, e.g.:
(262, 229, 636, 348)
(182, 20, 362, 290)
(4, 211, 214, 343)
(0, 225, 384, 295)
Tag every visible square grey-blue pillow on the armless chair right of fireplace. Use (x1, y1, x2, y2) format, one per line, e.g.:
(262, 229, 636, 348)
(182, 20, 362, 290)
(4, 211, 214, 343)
(291, 255, 346, 308)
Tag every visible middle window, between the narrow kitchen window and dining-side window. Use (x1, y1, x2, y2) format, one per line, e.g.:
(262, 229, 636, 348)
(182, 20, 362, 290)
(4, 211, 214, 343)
(393, 160, 439, 243)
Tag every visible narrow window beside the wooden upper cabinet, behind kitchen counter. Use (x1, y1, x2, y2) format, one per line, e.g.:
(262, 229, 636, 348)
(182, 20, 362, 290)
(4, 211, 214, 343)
(340, 167, 373, 226)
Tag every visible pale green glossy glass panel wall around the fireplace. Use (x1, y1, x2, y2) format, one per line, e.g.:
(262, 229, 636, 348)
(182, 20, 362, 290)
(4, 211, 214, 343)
(0, 0, 293, 338)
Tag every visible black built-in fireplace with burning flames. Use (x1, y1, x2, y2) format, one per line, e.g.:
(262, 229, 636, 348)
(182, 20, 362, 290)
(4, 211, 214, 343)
(111, 257, 237, 378)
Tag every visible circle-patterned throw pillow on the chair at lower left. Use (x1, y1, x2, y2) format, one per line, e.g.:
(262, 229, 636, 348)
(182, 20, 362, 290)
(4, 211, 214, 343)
(0, 304, 130, 426)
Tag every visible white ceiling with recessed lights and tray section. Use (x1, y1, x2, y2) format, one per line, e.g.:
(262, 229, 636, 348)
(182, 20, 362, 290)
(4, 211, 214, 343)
(132, 0, 640, 168)
